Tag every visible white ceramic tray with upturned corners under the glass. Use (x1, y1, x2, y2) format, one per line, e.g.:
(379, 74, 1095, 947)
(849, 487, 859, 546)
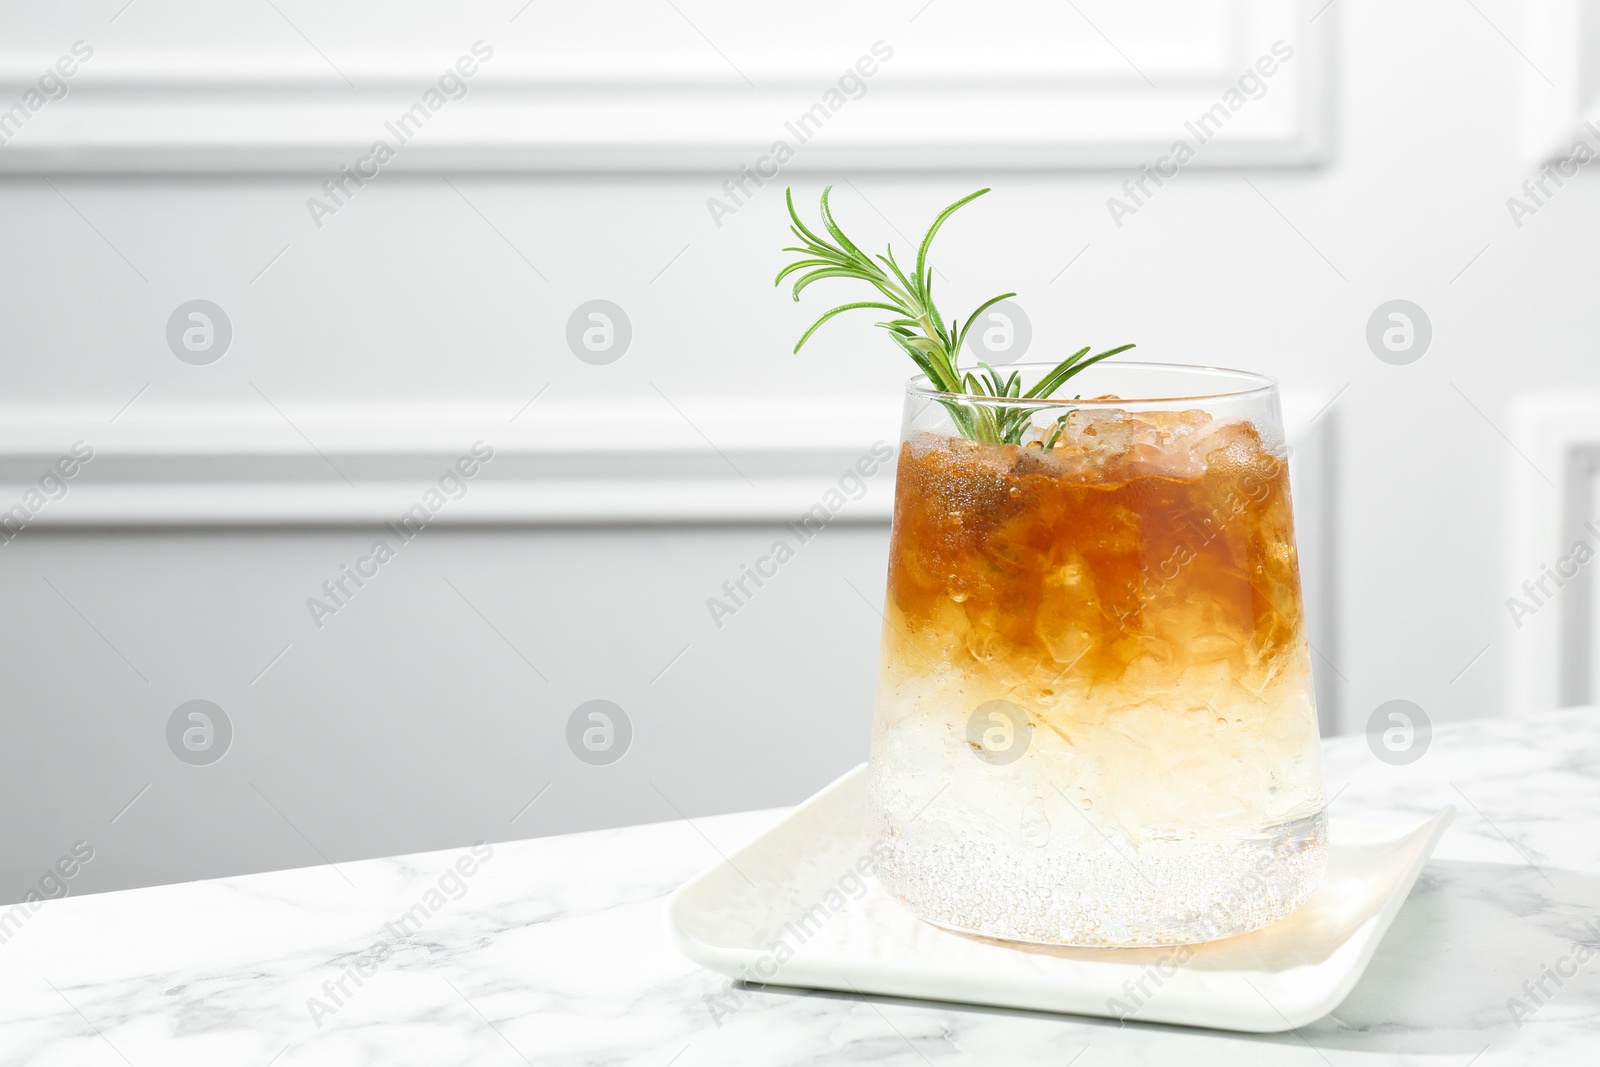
(667, 765, 1454, 1033)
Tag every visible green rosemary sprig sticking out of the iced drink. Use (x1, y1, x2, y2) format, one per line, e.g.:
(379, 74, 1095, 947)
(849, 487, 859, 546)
(773, 186, 1133, 445)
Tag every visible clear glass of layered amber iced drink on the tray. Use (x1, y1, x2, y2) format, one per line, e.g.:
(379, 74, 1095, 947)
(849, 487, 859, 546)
(869, 363, 1326, 945)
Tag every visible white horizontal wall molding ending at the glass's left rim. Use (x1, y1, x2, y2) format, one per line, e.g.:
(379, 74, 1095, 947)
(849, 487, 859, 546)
(0, 397, 899, 526)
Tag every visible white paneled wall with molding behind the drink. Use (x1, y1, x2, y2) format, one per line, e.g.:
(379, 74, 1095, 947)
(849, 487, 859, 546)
(0, 0, 1600, 899)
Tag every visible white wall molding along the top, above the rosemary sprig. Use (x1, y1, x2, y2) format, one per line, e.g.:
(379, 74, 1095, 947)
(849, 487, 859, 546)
(0, 0, 1331, 174)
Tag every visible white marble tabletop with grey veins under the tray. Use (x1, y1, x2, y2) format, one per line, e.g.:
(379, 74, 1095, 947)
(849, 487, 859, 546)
(0, 709, 1600, 1067)
